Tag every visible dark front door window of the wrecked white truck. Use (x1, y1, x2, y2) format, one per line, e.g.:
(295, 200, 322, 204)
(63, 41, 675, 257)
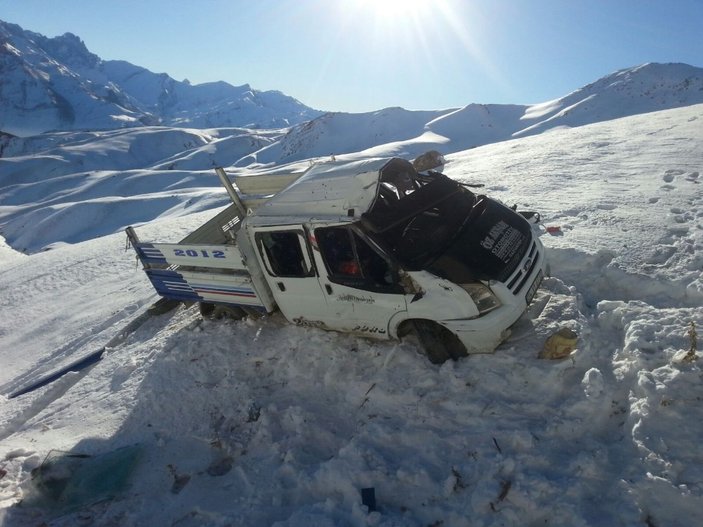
(315, 227, 397, 291)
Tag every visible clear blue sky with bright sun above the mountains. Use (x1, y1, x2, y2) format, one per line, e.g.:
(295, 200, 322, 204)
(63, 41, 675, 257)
(0, 0, 703, 112)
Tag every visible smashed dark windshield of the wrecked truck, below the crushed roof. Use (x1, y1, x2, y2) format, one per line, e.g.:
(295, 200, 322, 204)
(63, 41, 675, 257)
(362, 172, 476, 270)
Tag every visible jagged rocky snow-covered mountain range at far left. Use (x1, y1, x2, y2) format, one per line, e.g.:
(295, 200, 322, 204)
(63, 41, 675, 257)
(0, 21, 321, 136)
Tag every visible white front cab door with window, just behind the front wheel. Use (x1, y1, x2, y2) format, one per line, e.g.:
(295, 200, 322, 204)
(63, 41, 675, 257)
(313, 226, 407, 337)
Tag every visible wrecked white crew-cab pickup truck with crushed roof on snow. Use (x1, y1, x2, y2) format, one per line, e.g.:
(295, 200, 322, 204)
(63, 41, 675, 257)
(127, 158, 546, 363)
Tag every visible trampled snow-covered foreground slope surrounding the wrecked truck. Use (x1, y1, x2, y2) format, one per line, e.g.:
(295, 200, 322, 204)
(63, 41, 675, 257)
(0, 105, 703, 527)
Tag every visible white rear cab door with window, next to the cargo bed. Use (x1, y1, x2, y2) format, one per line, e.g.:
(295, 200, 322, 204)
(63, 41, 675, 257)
(254, 225, 327, 328)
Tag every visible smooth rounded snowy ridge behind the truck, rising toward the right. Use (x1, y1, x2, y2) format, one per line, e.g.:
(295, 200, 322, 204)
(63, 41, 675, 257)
(264, 60, 703, 166)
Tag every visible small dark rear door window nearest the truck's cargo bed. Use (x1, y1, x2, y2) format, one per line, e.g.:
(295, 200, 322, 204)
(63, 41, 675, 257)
(256, 231, 312, 277)
